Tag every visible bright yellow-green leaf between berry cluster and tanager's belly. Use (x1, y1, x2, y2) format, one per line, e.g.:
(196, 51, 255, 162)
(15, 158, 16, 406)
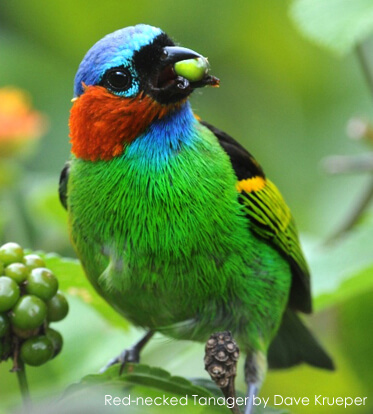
(43, 253, 129, 329)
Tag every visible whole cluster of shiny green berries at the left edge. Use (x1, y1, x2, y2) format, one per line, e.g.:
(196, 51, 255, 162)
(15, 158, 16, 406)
(0, 243, 69, 368)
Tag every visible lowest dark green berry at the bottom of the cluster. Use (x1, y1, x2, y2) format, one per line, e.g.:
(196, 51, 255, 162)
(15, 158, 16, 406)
(20, 336, 54, 367)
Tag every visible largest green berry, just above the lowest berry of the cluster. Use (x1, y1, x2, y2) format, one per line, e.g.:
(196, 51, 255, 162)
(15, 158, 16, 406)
(10, 295, 47, 331)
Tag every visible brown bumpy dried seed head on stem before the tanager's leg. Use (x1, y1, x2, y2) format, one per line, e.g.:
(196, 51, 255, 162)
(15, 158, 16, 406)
(204, 331, 241, 414)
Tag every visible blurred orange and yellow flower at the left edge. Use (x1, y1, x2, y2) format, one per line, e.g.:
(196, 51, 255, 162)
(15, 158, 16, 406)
(0, 87, 47, 158)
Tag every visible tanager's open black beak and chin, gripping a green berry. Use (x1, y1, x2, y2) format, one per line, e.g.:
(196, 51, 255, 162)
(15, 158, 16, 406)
(149, 46, 219, 104)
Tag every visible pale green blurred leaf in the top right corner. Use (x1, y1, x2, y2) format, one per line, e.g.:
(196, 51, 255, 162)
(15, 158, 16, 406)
(290, 0, 373, 55)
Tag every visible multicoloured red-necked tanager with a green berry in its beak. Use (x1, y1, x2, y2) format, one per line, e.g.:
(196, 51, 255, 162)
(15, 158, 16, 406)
(59, 24, 334, 414)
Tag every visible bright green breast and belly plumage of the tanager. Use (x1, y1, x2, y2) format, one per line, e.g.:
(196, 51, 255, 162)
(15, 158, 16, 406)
(68, 122, 290, 346)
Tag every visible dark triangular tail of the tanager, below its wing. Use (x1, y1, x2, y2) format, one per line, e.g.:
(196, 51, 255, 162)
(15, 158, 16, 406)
(268, 309, 334, 370)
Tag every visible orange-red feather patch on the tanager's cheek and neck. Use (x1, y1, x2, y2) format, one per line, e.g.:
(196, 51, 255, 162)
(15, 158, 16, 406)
(69, 86, 171, 161)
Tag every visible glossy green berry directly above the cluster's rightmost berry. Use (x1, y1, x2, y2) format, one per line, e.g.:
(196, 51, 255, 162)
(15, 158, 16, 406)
(26, 267, 58, 301)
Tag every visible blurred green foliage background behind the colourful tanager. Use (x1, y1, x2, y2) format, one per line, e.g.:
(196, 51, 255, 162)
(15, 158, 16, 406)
(0, 0, 373, 413)
